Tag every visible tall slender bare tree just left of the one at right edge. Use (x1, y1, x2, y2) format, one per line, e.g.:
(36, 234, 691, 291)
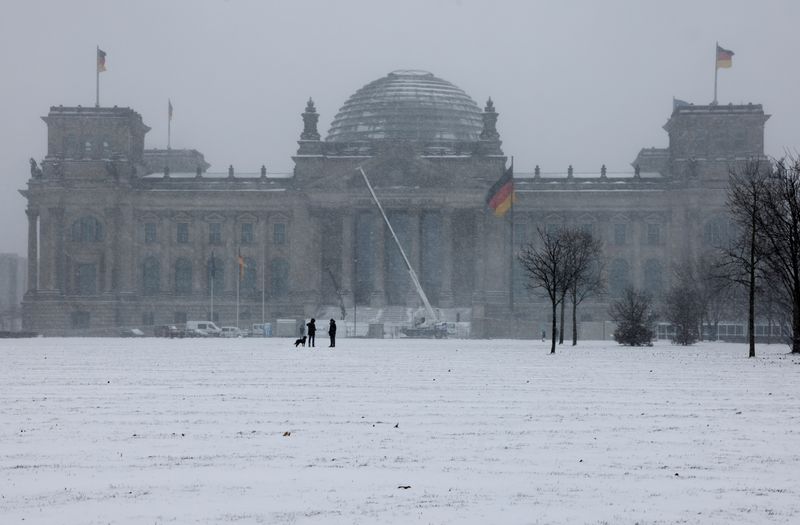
(727, 160, 768, 357)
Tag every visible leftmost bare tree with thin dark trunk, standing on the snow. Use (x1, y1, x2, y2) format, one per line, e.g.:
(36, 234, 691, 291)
(518, 228, 573, 354)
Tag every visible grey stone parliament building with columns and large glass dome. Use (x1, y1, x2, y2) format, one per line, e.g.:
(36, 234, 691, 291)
(22, 71, 768, 337)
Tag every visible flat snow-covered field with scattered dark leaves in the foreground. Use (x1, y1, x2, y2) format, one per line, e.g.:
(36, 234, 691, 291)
(0, 337, 800, 525)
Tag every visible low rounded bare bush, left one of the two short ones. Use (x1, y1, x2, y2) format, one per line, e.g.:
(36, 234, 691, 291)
(608, 287, 656, 346)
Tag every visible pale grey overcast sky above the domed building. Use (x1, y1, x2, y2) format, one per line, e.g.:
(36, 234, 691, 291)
(0, 0, 800, 255)
